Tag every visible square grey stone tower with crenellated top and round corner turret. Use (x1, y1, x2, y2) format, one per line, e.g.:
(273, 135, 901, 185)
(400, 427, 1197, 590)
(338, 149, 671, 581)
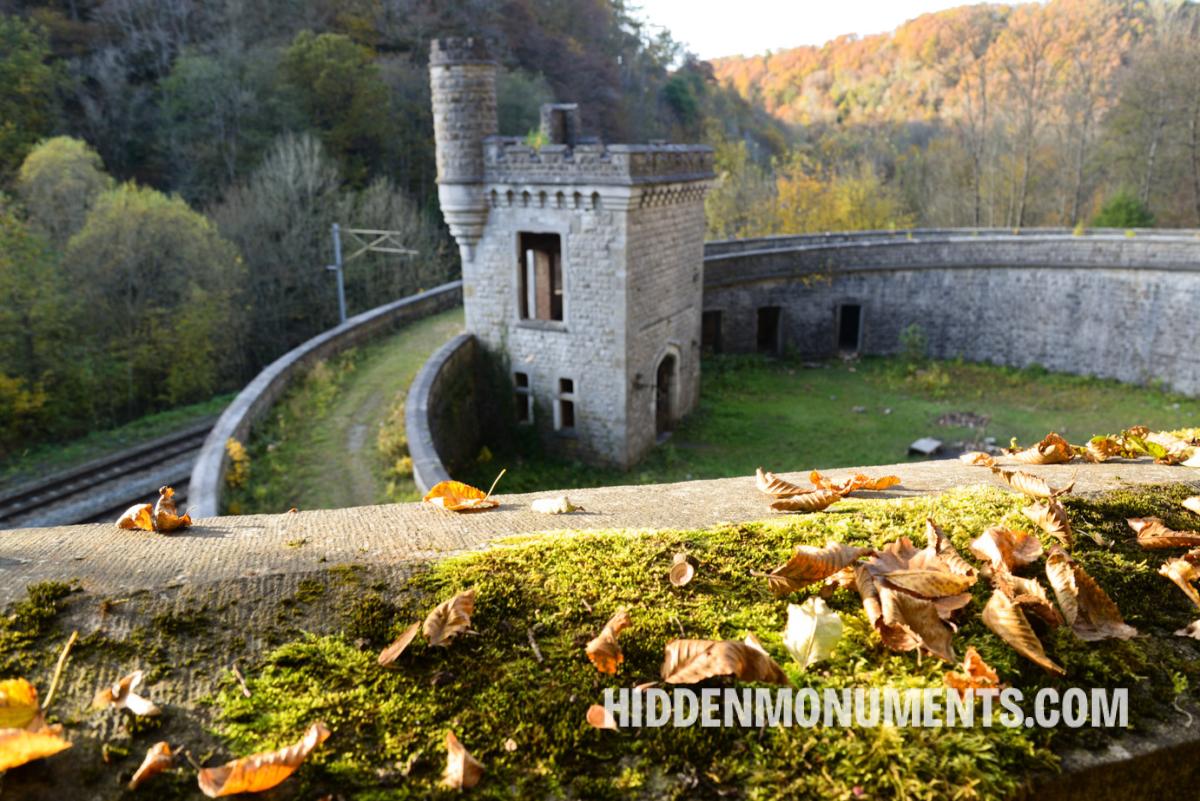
(430, 40, 713, 466)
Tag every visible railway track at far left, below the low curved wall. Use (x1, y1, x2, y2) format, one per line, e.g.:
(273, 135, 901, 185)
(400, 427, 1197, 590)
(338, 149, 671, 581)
(0, 418, 215, 530)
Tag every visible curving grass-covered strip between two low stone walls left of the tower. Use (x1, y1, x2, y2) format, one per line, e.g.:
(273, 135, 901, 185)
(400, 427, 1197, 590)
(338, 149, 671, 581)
(226, 309, 462, 514)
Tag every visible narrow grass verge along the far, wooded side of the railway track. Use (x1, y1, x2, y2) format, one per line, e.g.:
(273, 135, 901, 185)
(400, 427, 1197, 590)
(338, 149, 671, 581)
(0, 392, 234, 483)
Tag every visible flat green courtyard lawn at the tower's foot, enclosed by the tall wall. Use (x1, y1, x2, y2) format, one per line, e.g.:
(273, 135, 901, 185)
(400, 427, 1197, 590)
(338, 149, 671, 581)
(462, 356, 1200, 493)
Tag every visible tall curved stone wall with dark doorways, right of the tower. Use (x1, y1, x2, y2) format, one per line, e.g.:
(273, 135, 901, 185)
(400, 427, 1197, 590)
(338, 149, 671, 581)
(704, 229, 1200, 393)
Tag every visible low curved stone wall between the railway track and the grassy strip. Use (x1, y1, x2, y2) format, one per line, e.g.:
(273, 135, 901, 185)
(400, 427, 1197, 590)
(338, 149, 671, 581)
(187, 281, 462, 518)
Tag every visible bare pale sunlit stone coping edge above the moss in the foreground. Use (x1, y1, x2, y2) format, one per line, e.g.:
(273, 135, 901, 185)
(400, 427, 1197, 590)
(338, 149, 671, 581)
(0, 459, 1200, 604)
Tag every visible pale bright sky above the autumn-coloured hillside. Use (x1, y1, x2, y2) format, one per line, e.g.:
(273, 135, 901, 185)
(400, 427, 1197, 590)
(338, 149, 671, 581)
(630, 0, 1041, 59)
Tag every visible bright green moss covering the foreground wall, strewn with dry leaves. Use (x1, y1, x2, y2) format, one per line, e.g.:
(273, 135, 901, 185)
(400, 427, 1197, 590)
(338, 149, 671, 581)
(217, 488, 1200, 799)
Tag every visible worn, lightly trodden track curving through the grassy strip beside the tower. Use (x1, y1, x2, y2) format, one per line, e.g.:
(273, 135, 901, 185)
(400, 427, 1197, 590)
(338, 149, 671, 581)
(288, 308, 462, 508)
